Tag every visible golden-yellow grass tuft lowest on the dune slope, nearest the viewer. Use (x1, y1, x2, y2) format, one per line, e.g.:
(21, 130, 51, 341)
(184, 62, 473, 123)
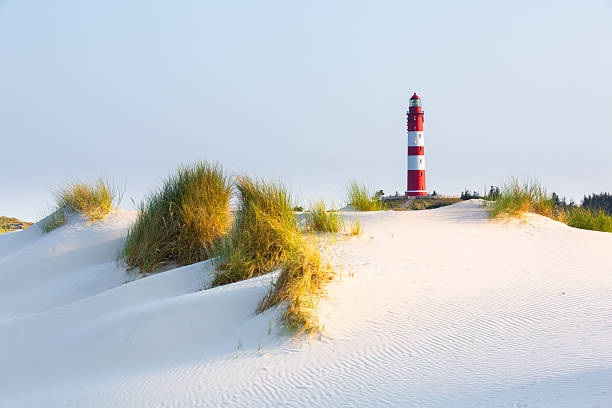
(257, 243, 334, 333)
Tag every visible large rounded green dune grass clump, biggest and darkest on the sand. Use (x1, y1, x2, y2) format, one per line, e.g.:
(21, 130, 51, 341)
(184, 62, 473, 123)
(122, 162, 232, 272)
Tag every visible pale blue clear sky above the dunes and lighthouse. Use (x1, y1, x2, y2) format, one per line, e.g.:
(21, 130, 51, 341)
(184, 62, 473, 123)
(0, 0, 612, 220)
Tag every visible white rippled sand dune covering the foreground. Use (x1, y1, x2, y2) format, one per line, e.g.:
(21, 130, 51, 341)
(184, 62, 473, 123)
(0, 200, 612, 407)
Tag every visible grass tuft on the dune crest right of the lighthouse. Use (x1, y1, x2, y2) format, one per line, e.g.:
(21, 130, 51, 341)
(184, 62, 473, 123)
(489, 178, 556, 218)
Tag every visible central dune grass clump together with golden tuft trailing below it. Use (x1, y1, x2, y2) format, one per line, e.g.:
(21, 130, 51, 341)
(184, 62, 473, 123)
(211, 177, 333, 332)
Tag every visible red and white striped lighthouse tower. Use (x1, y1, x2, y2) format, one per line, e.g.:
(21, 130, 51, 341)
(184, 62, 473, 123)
(406, 92, 427, 196)
